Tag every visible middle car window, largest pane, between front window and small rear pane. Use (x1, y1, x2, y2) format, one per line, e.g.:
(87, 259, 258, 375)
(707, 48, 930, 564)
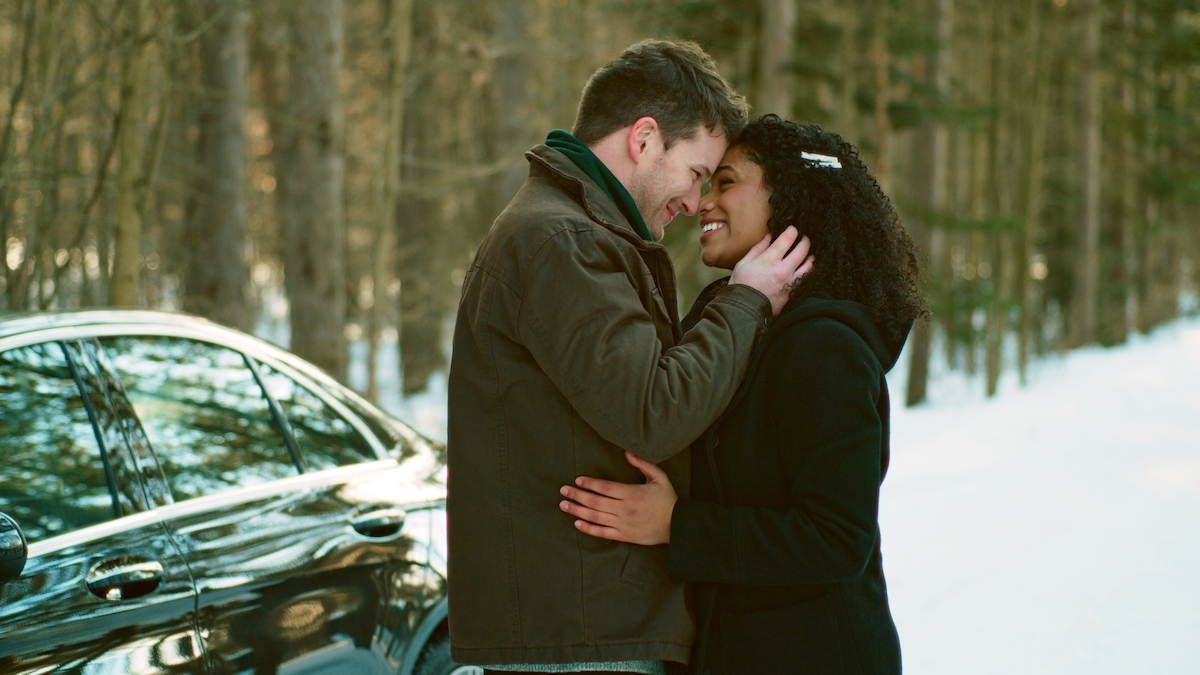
(101, 336, 298, 501)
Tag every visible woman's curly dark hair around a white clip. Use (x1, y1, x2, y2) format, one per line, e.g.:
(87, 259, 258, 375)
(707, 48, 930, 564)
(733, 115, 929, 340)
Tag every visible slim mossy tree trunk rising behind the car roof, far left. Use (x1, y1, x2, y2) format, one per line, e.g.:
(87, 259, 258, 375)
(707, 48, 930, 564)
(108, 0, 150, 306)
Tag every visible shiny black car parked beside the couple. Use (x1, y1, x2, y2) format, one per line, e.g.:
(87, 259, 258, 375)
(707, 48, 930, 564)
(0, 311, 480, 675)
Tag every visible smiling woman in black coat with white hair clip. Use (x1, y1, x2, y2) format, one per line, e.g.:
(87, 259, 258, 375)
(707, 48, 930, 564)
(560, 115, 925, 675)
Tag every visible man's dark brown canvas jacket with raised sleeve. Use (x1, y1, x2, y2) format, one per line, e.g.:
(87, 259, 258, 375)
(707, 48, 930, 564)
(448, 145, 770, 664)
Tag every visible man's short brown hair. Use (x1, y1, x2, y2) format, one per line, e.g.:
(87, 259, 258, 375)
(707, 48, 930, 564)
(572, 40, 750, 148)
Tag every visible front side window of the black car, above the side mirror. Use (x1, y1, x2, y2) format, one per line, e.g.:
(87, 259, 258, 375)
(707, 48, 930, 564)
(0, 342, 115, 543)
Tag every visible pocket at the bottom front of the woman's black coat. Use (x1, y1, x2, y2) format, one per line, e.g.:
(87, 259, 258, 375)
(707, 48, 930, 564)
(718, 595, 845, 675)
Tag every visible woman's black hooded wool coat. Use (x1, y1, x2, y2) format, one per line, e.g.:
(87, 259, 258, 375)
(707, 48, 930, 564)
(670, 285, 904, 675)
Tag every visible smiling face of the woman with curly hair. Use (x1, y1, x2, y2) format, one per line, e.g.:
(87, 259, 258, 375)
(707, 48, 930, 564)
(697, 145, 770, 269)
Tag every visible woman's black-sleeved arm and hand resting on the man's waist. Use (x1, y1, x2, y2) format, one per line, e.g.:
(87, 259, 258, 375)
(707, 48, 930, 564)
(564, 319, 882, 585)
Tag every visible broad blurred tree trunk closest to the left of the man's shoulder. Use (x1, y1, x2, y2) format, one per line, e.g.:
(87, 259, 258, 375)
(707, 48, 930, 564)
(397, 2, 497, 396)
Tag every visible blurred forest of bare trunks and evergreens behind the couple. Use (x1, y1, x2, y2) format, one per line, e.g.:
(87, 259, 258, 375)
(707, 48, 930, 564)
(0, 0, 1200, 405)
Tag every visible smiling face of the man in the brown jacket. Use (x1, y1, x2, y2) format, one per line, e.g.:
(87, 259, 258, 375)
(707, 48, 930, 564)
(629, 125, 727, 241)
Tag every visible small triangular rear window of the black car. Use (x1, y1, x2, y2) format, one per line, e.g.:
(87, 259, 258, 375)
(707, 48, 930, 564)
(258, 363, 376, 471)
